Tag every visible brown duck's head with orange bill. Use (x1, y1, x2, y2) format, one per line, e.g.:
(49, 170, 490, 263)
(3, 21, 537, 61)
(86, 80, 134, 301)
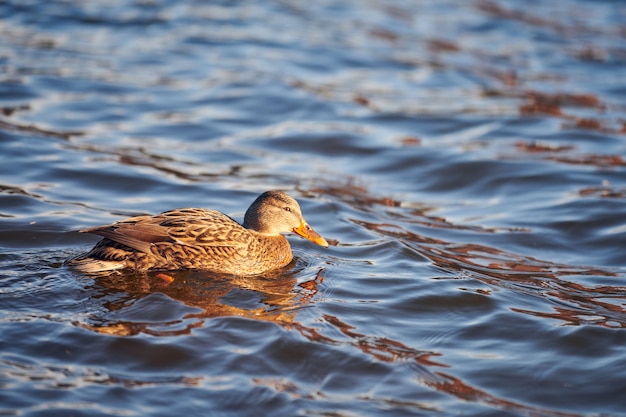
(243, 191, 328, 248)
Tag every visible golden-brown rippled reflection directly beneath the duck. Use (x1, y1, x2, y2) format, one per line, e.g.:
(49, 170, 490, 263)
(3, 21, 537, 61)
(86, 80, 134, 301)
(77, 262, 324, 336)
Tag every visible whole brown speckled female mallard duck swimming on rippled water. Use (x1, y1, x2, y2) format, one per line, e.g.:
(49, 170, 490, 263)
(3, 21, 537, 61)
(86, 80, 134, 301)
(69, 191, 328, 275)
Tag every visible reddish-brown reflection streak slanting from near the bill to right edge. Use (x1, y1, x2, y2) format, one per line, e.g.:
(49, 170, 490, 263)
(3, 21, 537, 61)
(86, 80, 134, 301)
(355, 221, 626, 327)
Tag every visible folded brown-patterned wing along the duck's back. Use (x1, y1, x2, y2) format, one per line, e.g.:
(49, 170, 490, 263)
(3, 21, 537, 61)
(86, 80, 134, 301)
(81, 208, 250, 253)
